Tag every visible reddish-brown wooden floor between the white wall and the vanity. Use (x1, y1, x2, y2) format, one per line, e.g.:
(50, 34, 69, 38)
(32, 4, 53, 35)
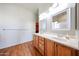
(0, 42, 41, 56)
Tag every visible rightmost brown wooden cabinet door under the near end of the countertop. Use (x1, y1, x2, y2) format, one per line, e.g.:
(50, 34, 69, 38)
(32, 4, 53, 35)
(56, 45, 75, 56)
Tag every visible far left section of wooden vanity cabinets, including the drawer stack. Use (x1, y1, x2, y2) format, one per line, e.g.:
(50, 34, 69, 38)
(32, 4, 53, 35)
(33, 35, 45, 55)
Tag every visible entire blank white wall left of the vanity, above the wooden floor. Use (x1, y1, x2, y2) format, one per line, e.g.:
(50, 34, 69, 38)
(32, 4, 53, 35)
(0, 4, 35, 48)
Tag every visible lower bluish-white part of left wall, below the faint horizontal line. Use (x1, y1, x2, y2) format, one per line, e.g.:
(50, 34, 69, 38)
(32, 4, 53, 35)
(0, 30, 32, 49)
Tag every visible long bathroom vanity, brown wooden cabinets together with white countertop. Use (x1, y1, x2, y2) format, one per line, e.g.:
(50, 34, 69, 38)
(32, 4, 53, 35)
(33, 33, 79, 56)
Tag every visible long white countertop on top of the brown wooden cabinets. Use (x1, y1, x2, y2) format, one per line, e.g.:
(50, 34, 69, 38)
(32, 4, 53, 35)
(34, 33, 79, 50)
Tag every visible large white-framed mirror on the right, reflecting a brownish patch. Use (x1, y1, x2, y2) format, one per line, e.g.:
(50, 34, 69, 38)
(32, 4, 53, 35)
(52, 8, 71, 30)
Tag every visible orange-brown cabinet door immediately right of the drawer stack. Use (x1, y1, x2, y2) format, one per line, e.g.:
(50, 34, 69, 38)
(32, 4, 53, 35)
(45, 39, 55, 56)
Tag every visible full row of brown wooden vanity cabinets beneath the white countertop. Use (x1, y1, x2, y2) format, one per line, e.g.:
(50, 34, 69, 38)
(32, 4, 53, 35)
(33, 35, 79, 56)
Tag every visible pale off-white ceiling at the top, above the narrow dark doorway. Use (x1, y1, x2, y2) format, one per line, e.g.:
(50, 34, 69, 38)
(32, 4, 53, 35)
(18, 3, 52, 14)
